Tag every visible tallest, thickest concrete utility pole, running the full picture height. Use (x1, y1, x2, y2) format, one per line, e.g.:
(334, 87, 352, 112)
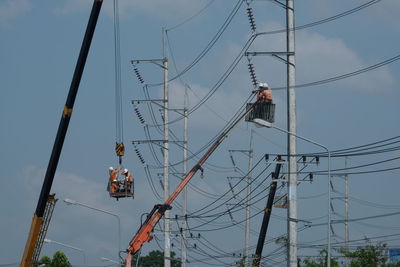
(286, 0, 297, 267)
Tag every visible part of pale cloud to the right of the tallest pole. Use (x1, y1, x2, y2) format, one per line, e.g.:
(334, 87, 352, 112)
(296, 31, 395, 93)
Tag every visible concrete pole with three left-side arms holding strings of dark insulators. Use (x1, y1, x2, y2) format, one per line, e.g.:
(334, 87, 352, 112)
(163, 29, 171, 267)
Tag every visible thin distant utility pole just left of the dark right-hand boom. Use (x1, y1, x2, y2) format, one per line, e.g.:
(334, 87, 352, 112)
(243, 129, 253, 266)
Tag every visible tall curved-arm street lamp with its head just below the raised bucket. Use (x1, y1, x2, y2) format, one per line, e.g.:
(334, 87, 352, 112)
(253, 119, 331, 267)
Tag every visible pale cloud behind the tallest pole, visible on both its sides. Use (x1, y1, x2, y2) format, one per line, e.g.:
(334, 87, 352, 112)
(254, 22, 395, 93)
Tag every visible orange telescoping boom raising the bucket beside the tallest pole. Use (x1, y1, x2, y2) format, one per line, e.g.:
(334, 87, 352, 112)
(125, 101, 252, 267)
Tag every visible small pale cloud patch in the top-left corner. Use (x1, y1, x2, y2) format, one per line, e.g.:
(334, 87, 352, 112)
(0, 0, 30, 25)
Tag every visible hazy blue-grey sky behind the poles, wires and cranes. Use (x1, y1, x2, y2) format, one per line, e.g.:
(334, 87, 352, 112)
(0, 0, 400, 266)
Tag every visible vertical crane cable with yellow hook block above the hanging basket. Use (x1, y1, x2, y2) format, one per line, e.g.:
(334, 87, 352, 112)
(113, 0, 125, 168)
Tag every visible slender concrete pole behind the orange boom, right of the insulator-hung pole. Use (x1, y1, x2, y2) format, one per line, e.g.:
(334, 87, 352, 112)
(181, 88, 188, 267)
